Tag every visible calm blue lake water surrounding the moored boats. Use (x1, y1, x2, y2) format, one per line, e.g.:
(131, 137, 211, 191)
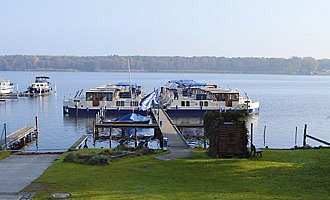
(0, 71, 330, 150)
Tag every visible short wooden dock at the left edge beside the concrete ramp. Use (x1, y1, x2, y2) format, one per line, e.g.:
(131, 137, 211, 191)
(0, 126, 38, 150)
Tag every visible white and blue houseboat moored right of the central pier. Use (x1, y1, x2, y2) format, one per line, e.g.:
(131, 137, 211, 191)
(160, 80, 259, 116)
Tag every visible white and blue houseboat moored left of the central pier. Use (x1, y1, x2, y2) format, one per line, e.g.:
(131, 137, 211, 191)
(63, 82, 145, 116)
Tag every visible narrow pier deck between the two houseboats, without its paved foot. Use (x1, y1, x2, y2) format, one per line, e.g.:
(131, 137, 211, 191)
(152, 109, 188, 147)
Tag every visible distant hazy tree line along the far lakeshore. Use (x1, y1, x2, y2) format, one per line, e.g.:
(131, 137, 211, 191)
(0, 55, 330, 75)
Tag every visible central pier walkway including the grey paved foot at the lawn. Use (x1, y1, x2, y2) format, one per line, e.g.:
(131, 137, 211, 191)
(152, 109, 193, 160)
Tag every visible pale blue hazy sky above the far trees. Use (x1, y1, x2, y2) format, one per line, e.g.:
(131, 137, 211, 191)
(0, 0, 330, 58)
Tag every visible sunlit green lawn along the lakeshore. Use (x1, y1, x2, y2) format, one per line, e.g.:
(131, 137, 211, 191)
(26, 149, 330, 199)
